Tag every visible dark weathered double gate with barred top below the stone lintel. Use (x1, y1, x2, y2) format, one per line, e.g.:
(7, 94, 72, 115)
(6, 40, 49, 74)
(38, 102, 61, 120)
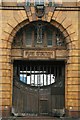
(12, 60, 65, 116)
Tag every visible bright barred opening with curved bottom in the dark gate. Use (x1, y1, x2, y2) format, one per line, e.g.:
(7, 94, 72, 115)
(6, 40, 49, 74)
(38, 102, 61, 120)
(20, 71, 55, 86)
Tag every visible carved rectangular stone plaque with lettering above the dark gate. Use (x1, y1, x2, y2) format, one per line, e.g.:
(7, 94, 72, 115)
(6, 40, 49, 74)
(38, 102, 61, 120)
(23, 50, 55, 59)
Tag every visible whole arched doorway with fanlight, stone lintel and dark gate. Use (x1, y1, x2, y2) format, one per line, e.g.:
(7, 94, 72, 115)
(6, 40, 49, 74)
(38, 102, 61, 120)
(12, 21, 66, 116)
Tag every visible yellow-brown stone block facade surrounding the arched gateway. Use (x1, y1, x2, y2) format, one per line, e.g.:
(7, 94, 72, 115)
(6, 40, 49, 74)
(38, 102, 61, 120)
(0, 1, 80, 116)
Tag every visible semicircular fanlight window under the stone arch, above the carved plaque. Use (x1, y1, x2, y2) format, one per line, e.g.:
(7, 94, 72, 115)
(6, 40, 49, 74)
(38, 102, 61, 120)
(13, 21, 66, 48)
